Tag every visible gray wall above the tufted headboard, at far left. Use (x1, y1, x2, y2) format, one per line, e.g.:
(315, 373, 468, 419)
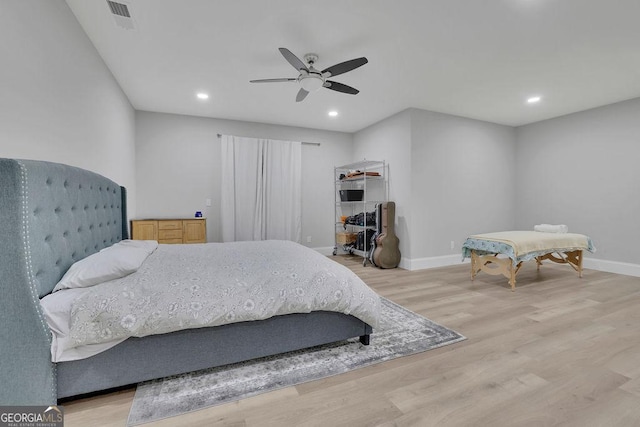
(0, 0, 136, 215)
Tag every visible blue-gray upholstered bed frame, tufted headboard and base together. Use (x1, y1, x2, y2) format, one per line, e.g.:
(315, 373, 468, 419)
(0, 159, 377, 405)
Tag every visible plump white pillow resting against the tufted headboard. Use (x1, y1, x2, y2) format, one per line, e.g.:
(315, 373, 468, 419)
(53, 240, 158, 292)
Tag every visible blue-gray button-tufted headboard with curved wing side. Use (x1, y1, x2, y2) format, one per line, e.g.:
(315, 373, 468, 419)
(0, 159, 128, 405)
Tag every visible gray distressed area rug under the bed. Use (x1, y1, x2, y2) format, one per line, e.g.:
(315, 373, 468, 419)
(128, 298, 466, 426)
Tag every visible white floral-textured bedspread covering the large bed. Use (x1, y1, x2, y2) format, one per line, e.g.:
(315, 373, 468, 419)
(42, 241, 380, 362)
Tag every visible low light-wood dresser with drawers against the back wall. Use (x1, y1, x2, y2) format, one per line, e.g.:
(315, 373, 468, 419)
(131, 218, 207, 243)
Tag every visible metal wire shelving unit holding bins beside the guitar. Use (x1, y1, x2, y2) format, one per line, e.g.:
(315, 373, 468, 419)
(333, 160, 389, 265)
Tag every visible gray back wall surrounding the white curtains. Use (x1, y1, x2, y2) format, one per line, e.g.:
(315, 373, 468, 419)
(136, 111, 352, 247)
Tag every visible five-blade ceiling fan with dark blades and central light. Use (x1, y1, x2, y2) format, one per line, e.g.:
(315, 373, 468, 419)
(250, 47, 369, 102)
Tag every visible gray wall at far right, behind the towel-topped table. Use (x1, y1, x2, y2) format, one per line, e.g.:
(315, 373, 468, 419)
(516, 99, 640, 264)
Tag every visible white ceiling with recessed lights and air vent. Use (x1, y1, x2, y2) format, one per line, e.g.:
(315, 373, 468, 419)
(67, 0, 640, 132)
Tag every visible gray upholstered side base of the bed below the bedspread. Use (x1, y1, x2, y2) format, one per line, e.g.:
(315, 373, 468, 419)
(57, 311, 371, 398)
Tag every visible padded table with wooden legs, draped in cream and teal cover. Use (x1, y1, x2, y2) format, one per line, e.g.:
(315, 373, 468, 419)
(462, 231, 595, 291)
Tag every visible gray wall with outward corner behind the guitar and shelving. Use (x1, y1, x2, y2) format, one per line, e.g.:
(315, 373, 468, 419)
(354, 109, 515, 269)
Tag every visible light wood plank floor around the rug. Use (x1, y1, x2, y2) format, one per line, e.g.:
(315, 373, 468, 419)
(64, 256, 640, 427)
